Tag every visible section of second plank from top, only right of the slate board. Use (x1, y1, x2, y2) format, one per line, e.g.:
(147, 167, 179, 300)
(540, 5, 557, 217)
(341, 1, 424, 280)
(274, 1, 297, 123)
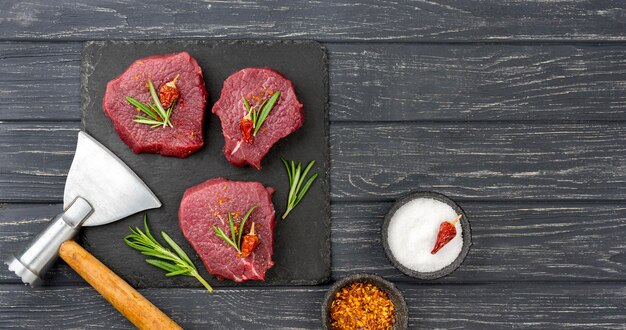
(328, 44, 626, 122)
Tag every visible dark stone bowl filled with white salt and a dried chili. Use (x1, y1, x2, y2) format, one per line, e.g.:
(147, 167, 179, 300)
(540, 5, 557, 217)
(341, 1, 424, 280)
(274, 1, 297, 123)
(382, 191, 472, 280)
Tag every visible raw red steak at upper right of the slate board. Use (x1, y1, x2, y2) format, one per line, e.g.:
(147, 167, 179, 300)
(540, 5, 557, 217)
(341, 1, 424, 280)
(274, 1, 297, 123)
(213, 68, 304, 170)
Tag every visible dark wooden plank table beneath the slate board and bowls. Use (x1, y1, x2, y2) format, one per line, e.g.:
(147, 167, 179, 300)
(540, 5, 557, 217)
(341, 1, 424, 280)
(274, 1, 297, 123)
(0, 0, 626, 329)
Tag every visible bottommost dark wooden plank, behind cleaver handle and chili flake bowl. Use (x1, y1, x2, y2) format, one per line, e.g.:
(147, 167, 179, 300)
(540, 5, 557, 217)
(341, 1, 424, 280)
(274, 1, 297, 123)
(0, 283, 626, 329)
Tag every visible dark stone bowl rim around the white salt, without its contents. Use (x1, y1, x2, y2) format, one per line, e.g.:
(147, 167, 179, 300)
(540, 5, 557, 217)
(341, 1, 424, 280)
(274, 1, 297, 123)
(382, 191, 472, 280)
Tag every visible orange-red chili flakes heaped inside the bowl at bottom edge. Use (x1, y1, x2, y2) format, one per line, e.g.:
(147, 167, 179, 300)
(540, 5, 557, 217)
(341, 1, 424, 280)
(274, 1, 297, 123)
(330, 282, 394, 330)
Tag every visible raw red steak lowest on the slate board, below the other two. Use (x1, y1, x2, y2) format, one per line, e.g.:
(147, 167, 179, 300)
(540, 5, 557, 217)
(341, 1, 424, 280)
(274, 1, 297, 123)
(178, 178, 274, 282)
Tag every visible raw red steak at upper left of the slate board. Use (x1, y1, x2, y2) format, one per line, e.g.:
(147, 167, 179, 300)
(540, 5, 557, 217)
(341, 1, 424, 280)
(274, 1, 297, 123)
(102, 52, 207, 158)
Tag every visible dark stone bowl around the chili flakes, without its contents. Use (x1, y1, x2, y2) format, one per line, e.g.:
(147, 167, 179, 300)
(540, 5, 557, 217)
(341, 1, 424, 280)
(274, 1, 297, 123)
(322, 274, 409, 330)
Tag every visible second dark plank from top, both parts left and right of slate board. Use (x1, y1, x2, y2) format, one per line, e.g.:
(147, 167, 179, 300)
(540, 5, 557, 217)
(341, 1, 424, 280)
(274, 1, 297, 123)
(0, 42, 626, 122)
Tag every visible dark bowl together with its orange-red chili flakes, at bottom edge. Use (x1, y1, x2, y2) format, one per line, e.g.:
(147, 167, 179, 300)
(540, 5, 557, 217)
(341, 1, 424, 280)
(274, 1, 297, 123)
(322, 274, 409, 330)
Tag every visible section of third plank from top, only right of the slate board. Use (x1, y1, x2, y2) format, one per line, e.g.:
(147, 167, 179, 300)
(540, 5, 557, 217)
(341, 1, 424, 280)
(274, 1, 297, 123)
(331, 122, 626, 201)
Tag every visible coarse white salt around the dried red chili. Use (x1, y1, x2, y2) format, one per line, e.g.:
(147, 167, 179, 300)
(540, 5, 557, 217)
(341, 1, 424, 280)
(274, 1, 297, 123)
(387, 198, 463, 273)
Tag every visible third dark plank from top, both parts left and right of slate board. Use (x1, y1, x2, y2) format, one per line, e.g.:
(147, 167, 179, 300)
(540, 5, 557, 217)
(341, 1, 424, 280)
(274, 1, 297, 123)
(0, 122, 626, 202)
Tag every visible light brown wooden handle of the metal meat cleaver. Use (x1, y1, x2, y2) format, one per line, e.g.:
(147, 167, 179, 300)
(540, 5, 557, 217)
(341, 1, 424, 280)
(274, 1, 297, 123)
(59, 241, 182, 329)
